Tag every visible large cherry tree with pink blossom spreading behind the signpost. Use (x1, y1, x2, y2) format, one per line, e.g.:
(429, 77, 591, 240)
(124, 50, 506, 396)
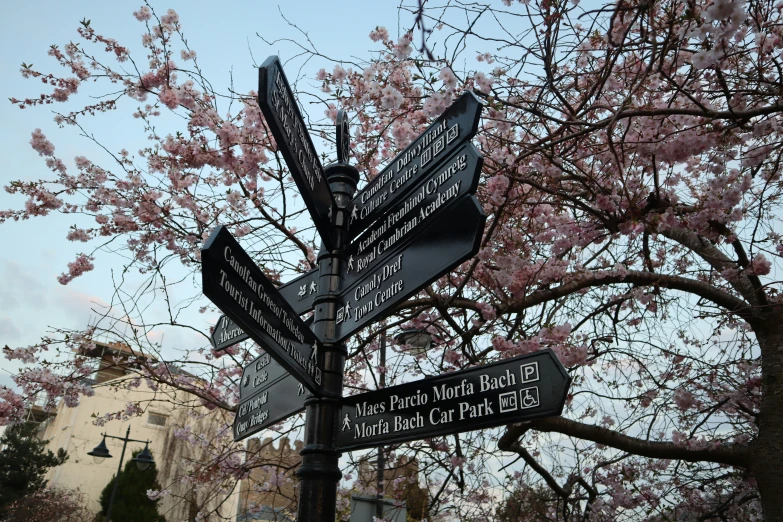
(0, 0, 783, 521)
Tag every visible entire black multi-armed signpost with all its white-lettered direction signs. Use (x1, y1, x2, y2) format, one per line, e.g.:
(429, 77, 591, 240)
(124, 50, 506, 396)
(201, 56, 571, 522)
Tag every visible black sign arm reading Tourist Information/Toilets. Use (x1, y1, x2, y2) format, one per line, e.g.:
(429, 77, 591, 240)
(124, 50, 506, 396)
(201, 225, 321, 394)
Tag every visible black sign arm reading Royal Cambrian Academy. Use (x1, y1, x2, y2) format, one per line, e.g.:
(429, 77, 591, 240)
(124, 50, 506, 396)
(342, 143, 484, 288)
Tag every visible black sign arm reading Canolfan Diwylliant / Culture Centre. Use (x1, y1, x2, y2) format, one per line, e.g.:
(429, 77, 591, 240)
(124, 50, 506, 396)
(348, 91, 482, 237)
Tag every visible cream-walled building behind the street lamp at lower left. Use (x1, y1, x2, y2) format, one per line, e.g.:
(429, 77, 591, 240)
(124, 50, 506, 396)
(28, 343, 238, 522)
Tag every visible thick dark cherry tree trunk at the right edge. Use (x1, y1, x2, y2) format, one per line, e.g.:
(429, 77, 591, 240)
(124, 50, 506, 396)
(750, 305, 783, 522)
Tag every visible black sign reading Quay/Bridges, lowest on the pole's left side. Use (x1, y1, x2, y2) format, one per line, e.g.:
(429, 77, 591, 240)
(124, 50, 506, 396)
(234, 375, 309, 441)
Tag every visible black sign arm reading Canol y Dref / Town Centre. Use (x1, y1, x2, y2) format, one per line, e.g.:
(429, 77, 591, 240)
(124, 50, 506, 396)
(335, 196, 486, 342)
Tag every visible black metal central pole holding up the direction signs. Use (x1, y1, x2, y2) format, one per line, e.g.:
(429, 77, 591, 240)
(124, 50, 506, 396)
(296, 158, 359, 522)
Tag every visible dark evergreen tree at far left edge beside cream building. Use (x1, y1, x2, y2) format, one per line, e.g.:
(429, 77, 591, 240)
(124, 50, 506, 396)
(0, 423, 68, 517)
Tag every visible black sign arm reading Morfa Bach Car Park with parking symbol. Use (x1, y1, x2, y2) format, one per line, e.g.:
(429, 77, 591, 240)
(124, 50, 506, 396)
(338, 350, 571, 451)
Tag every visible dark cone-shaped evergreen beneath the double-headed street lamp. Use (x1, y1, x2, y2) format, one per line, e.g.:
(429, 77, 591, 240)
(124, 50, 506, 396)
(100, 450, 166, 522)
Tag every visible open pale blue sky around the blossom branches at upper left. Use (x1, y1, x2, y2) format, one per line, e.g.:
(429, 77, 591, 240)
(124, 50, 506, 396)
(0, 0, 412, 385)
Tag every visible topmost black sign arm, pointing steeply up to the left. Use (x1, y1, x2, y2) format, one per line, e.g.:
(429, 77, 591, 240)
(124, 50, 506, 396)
(258, 56, 335, 248)
